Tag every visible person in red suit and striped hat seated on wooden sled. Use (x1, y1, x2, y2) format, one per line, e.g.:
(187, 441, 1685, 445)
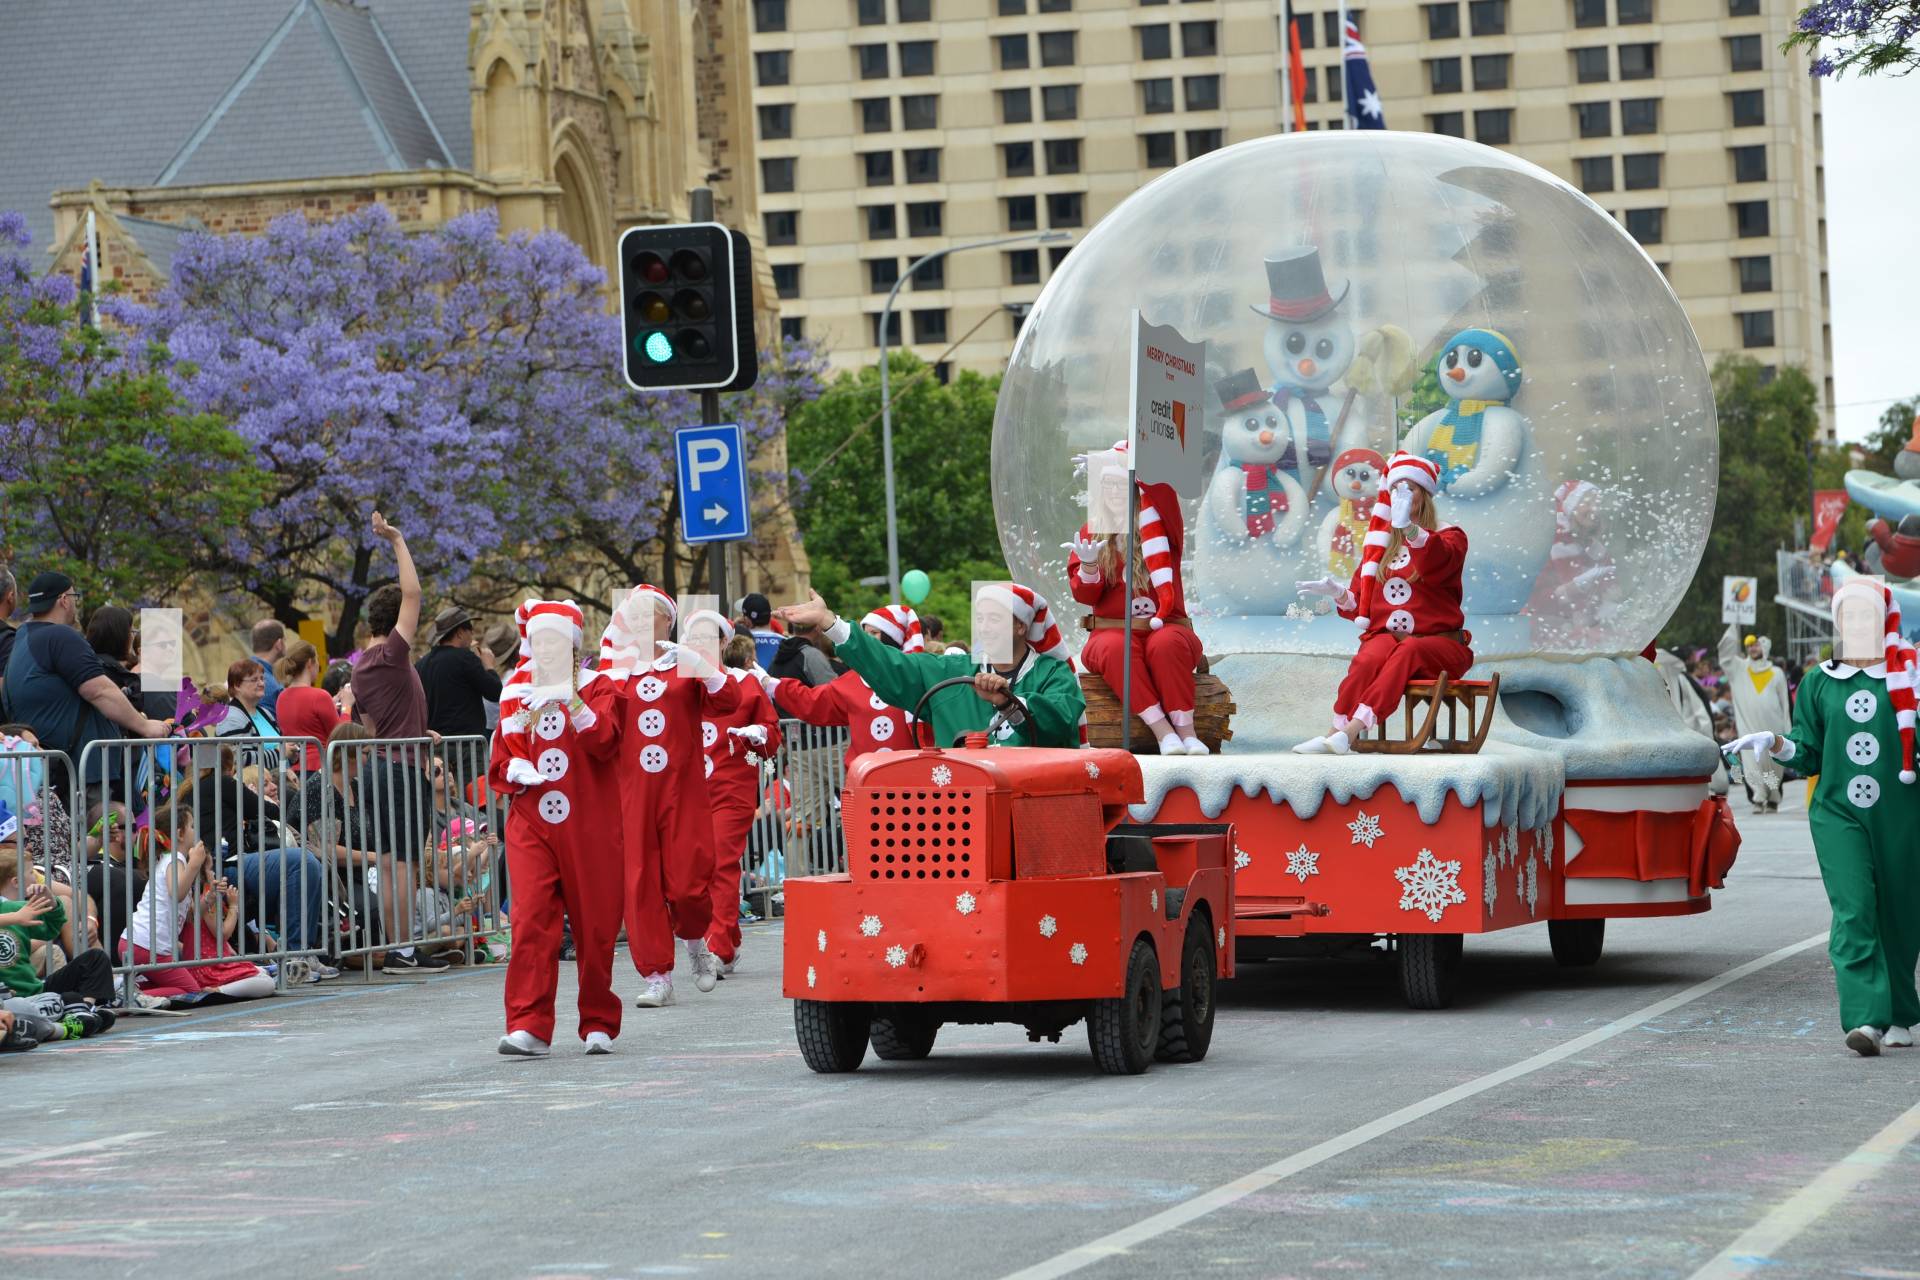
(1294, 451, 1473, 756)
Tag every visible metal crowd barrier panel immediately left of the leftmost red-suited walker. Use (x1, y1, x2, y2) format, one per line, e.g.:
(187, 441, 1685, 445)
(321, 735, 507, 973)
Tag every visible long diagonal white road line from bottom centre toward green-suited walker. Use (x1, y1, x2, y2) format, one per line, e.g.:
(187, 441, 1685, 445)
(1006, 933, 1827, 1280)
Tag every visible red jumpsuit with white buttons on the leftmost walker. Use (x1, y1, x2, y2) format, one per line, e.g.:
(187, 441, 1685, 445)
(488, 679, 624, 1044)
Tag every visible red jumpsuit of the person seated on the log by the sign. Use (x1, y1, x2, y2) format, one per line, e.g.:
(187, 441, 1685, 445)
(1068, 484, 1202, 716)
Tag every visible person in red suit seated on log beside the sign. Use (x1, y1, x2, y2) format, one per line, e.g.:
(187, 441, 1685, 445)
(1066, 441, 1208, 756)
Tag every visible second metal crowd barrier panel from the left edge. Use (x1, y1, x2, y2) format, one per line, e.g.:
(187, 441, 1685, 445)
(63, 735, 332, 1004)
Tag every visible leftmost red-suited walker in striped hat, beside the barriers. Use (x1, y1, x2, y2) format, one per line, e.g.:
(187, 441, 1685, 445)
(488, 601, 624, 1057)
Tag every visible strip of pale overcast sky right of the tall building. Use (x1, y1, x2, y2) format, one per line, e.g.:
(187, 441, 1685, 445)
(1820, 73, 1920, 449)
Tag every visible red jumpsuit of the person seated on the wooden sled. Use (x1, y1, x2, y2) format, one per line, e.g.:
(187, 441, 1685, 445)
(1332, 524, 1473, 727)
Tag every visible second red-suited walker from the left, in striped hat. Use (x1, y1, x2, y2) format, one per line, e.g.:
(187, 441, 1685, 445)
(599, 585, 739, 1009)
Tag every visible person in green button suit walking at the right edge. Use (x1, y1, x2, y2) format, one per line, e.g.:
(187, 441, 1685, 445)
(1732, 578, 1920, 1057)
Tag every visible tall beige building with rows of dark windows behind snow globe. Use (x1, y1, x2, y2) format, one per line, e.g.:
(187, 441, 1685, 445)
(751, 0, 1834, 432)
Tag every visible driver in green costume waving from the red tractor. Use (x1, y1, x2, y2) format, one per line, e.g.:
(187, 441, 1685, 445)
(780, 583, 1087, 747)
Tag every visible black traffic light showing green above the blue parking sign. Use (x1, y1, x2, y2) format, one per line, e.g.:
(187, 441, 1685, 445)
(620, 223, 760, 391)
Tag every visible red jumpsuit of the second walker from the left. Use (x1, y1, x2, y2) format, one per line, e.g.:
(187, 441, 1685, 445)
(610, 658, 739, 977)
